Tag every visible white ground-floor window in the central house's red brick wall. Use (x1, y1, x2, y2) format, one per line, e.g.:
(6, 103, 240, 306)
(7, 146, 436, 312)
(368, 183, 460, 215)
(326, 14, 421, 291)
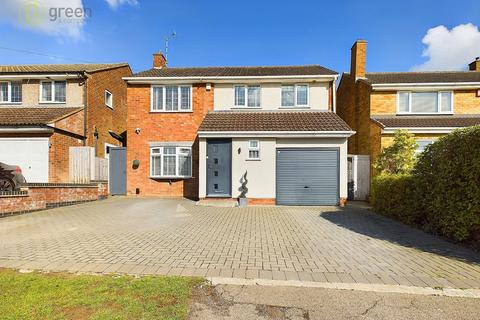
(150, 146, 192, 179)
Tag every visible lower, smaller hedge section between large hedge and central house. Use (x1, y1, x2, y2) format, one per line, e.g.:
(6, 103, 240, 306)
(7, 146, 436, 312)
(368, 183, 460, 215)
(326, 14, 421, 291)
(370, 174, 421, 225)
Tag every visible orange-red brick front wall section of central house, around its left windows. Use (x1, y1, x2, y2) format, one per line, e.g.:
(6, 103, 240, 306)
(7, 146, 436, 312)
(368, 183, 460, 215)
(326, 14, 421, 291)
(127, 84, 214, 198)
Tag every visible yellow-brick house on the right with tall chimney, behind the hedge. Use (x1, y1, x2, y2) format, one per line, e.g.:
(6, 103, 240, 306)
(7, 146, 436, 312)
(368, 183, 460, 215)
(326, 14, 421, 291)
(337, 40, 480, 196)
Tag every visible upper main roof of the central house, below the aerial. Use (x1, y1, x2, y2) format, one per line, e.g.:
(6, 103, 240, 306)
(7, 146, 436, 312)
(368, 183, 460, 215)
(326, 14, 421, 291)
(133, 65, 337, 77)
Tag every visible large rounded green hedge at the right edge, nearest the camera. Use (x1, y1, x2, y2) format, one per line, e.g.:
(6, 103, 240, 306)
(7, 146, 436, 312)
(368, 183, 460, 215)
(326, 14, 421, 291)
(414, 126, 480, 244)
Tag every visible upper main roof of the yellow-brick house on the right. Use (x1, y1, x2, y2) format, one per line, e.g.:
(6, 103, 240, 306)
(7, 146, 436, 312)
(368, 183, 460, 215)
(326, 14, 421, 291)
(365, 71, 480, 84)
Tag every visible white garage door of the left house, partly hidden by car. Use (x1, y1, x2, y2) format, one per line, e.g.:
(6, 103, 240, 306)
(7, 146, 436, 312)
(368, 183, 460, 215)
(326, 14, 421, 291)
(0, 138, 48, 182)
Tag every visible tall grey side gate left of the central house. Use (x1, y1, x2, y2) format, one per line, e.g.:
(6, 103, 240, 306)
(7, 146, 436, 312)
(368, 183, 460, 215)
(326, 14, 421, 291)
(108, 147, 127, 195)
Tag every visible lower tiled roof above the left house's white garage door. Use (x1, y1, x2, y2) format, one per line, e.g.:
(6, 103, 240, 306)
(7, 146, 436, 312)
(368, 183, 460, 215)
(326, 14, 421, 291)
(0, 107, 83, 126)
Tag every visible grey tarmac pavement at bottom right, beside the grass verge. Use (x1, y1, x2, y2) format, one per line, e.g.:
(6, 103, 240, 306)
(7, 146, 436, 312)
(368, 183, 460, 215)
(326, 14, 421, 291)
(189, 285, 480, 320)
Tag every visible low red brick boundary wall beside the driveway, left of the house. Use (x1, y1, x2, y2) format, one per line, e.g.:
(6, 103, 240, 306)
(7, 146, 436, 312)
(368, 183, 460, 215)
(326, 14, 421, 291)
(0, 183, 108, 216)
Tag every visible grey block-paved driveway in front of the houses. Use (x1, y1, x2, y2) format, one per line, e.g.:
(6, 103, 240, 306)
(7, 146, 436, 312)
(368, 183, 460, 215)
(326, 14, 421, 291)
(0, 198, 480, 288)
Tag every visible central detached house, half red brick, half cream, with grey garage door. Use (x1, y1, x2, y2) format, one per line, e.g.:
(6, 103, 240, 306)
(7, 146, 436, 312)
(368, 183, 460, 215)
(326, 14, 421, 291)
(125, 53, 353, 205)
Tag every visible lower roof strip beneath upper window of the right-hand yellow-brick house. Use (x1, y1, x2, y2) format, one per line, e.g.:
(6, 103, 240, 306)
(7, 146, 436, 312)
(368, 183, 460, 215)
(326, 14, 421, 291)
(371, 114, 480, 128)
